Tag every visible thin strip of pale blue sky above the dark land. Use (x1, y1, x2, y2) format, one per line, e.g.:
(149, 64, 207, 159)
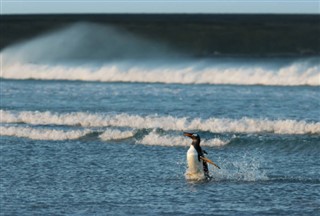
(0, 0, 320, 14)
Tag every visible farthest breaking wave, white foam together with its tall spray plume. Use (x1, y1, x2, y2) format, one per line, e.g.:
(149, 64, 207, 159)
(0, 23, 320, 86)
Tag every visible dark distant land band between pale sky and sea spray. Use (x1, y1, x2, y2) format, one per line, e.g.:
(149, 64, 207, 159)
(0, 14, 320, 57)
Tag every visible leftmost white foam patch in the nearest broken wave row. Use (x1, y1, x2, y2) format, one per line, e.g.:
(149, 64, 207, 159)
(0, 126, 90, 141)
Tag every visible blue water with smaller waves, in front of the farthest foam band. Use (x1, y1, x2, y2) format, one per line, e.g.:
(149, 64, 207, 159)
(1, 80, 320, 215)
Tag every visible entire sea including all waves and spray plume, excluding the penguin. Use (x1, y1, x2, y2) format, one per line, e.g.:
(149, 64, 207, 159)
(0, 23, 320, 215)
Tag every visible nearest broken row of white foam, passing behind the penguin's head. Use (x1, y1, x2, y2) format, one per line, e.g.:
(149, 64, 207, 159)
(0, 126, 229, 147)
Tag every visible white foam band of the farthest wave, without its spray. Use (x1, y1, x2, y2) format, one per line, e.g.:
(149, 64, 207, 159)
(0, 62, 320, 86)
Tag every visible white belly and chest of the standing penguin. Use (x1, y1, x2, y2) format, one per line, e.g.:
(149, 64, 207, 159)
(185, 145, 205, 180)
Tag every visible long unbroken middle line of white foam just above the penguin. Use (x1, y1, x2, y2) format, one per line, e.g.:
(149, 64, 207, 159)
(0, 110, 320, 134)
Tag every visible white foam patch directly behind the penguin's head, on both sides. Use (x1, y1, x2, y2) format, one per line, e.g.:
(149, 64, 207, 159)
(137, 131, 228, 147)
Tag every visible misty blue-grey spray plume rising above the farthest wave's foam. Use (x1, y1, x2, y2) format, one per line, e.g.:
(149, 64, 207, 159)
(1, 22, 178, 65)
